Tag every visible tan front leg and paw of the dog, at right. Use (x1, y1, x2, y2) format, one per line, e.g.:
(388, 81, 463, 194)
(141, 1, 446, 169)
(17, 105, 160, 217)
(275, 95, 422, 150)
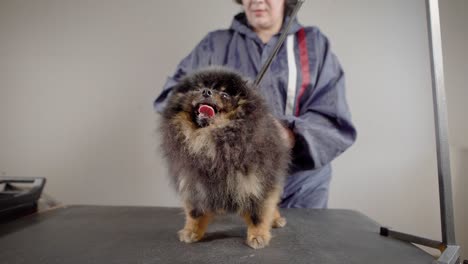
(243, 190, 279, 249)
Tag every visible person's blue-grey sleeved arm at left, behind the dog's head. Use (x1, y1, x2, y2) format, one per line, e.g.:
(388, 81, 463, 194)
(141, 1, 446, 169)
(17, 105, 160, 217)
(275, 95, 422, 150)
(153, 34, 214, 113)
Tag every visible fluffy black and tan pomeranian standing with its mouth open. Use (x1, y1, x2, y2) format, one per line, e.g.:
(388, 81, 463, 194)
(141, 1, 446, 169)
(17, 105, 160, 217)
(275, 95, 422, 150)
(160, 67, 291, 248)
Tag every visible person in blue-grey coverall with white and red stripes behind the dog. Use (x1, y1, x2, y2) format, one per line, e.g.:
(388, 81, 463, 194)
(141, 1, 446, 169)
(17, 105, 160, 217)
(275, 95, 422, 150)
(154, 0, 356, 208)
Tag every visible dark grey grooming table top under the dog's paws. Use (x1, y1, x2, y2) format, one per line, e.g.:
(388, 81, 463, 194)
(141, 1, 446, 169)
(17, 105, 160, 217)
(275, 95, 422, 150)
(0, 206, 434, 264)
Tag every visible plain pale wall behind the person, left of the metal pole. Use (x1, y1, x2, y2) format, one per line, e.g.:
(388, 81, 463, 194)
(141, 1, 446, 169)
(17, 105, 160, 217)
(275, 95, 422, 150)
(0, 0, 467, 260)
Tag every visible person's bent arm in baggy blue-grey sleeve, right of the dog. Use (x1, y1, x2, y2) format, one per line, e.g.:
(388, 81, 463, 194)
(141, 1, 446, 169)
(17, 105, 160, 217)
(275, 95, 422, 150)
(284, 29, 356, 169)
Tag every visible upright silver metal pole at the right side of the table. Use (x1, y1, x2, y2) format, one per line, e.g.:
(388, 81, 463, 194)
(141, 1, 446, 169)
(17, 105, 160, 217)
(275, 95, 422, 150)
(426, 0, 455, 245)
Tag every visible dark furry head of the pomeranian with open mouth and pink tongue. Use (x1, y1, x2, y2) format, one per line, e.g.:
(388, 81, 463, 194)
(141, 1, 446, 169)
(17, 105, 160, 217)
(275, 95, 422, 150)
(165, 69, 256, 128)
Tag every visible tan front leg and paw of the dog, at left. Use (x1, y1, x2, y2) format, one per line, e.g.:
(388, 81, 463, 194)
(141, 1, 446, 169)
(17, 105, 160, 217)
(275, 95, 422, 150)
(178, 205, 213, 243)
